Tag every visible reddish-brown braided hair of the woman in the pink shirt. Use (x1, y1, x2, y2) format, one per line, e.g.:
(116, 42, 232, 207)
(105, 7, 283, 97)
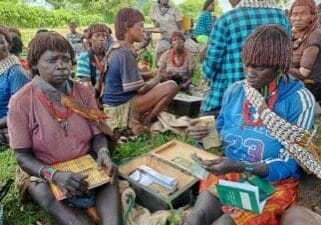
(27, 31, 75, 76)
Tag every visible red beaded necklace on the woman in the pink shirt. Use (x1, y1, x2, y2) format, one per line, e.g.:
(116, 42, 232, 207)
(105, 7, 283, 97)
(38, 81, 74, 136)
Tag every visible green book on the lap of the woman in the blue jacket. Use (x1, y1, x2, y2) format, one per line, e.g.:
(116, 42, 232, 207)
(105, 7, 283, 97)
(216, 180, 274, 214)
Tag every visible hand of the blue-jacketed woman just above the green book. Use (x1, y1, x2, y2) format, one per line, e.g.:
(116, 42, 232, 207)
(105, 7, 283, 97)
(203, 157, 244, 176)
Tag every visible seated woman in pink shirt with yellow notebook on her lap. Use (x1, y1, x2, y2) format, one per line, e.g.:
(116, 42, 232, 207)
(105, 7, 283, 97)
(8, 31, 120, 225)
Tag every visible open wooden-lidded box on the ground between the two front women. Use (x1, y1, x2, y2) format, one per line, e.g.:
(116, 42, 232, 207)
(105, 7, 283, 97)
(119, 140, 217, 211)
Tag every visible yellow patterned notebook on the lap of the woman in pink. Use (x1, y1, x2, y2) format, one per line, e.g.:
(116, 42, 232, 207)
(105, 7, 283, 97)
(50, 155, 110, 201)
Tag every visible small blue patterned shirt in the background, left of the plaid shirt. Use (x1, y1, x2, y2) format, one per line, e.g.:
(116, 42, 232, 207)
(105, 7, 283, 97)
(193, 10, 215, 37)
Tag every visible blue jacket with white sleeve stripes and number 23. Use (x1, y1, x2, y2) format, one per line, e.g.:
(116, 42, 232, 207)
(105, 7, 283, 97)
(217, 76, 315, 181)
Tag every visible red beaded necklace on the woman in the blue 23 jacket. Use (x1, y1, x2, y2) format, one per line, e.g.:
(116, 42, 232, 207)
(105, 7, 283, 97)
(242, 79, 278, 126)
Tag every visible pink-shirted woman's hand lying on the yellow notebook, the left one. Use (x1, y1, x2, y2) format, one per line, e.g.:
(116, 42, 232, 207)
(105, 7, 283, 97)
(52, 171, 88, 197)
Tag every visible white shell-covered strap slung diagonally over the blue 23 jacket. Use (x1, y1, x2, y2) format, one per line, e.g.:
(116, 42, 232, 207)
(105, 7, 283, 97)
(243, 81, 321, 178)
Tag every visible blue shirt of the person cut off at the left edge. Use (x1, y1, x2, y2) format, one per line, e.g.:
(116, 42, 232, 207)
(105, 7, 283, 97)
(0, 64, 29, 119)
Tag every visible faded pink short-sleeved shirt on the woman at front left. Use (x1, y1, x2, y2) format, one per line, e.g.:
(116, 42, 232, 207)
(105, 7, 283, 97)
(8, 82, 101, 165)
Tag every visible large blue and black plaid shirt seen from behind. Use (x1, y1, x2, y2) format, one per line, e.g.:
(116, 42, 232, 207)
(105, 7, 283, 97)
(201, 8, 291, 112)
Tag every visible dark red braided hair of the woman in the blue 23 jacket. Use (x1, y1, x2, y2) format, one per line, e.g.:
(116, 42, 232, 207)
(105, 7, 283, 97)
(242, 25, 292, 74)
